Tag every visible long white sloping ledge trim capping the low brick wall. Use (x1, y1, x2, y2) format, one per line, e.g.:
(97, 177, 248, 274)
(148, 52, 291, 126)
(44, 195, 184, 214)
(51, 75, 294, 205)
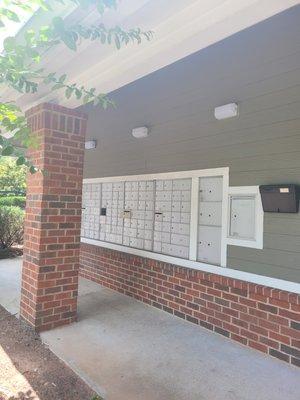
(81, 238, 300, 294)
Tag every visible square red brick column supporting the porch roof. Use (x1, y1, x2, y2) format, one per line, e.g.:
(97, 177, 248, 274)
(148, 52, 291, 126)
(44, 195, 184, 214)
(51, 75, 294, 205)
(20, 103, 87, 331)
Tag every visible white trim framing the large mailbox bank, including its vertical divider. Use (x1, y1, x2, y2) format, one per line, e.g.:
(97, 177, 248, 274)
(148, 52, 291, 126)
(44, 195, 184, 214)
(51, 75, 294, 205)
(82, 167, 229, 267)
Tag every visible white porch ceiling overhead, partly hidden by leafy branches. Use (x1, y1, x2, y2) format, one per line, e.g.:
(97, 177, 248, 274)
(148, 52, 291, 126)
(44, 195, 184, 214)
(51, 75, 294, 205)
(2, 0, 299, 109)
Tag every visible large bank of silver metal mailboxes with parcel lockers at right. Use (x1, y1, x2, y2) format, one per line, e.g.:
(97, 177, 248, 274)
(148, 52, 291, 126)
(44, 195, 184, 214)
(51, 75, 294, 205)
(82, 169, 228, 265)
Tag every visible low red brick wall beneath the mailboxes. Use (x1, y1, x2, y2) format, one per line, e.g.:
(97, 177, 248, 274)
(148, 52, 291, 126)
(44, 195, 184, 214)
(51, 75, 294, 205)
(80, 244, 300, 366)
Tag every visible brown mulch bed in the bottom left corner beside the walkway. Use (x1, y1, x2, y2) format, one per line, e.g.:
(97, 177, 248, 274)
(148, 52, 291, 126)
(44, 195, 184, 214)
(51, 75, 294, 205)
(0, 306, 101, 400)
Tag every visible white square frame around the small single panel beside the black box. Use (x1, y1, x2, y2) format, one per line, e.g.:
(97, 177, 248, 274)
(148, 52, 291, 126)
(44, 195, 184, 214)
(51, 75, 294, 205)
(226, 186, 264, 249)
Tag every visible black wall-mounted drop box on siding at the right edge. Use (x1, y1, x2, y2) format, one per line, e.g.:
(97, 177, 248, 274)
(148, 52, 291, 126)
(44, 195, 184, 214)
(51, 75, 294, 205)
(259, 184, 299, 213)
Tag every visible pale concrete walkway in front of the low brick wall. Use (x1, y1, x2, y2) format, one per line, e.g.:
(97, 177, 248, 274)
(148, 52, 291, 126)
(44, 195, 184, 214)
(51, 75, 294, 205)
(0, 261, 300, 400)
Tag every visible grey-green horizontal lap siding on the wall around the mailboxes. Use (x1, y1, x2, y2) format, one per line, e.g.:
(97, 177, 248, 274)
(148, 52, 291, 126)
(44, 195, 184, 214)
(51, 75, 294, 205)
(81, 6, 300, 282)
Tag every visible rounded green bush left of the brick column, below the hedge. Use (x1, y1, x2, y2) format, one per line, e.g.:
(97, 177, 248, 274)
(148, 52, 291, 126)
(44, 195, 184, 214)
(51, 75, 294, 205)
(0, 206, 25, 249)
